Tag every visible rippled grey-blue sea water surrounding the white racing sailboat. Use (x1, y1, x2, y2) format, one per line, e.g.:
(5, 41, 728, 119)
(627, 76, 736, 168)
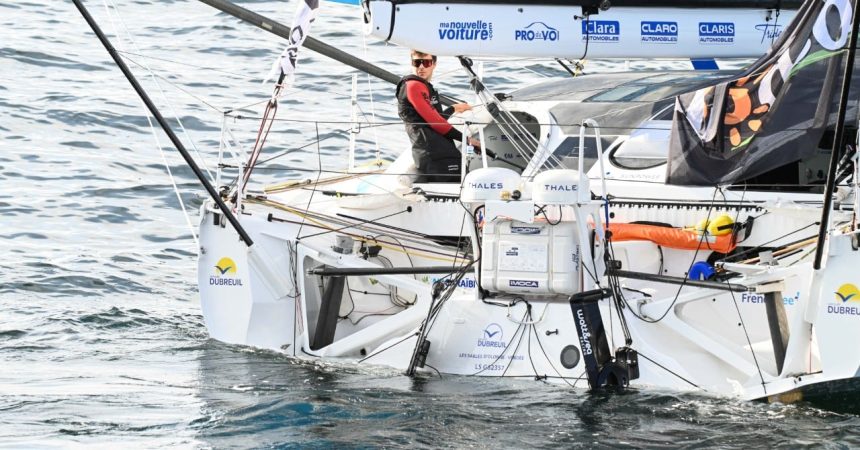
(5, 0, 860, 448)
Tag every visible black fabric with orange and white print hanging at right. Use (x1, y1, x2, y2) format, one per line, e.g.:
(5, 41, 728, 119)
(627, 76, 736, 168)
(667, 0, 857, 185)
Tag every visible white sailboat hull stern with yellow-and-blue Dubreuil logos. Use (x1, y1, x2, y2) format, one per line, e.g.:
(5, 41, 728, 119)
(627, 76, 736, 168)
(199, 168, 860, 399)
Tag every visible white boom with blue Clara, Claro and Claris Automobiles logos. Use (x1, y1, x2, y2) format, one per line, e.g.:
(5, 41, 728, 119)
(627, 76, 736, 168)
(362, 0, 800, 59)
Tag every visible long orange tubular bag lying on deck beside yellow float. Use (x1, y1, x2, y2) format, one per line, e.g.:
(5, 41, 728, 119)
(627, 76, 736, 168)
(609, 223, 737, 253)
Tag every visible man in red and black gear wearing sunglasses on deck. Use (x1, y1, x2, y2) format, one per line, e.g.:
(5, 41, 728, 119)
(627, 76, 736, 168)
(397, 50, 480, 183)
